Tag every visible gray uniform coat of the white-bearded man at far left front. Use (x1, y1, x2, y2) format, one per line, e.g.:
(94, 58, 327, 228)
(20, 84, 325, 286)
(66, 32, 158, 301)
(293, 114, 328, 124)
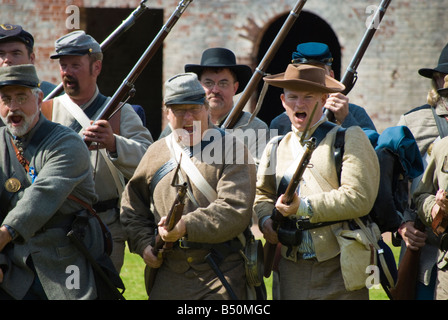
(0, 115, 104, 300)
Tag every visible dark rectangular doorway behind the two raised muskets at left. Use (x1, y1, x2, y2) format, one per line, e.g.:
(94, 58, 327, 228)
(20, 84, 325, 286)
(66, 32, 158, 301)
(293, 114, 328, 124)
(82, 8, 163, 137)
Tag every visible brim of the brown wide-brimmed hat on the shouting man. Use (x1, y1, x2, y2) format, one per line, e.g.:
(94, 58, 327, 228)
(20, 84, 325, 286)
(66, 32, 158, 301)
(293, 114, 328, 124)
(263, 72, 345, 93)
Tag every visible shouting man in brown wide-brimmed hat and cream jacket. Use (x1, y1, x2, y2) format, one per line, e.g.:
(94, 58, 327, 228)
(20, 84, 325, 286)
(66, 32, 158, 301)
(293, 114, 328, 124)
(254, 64, 379, 300)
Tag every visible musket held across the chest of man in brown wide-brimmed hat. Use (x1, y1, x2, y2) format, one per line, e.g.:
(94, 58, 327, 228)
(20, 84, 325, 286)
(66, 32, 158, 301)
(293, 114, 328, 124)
(263, 137, 316, 278)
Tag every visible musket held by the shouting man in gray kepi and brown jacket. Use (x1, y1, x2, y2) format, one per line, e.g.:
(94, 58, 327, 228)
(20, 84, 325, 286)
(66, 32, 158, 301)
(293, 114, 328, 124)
(145, 156, 187, 296)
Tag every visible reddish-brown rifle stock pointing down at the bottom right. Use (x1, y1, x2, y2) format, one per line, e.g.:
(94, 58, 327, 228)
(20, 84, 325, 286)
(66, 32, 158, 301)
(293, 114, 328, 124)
(390, 217, 425, 300)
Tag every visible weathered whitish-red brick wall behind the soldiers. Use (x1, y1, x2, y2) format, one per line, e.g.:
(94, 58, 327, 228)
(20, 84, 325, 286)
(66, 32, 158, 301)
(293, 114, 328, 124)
(0, 0, 448, 131)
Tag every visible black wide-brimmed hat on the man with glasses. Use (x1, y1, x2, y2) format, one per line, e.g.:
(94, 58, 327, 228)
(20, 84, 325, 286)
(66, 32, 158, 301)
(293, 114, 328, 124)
(184, 48, 252, 94)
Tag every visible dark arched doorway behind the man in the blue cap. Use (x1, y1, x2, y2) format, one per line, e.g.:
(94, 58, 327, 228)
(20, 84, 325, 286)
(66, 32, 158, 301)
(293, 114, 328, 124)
(257, 11, 341, 125)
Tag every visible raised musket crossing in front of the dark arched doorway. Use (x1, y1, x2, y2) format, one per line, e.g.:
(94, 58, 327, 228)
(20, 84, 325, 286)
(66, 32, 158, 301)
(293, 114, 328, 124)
(221, 0, 306, 129)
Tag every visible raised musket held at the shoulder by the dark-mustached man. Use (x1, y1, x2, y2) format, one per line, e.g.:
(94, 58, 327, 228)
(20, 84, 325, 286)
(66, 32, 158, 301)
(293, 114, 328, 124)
(86, 0, 193, 146)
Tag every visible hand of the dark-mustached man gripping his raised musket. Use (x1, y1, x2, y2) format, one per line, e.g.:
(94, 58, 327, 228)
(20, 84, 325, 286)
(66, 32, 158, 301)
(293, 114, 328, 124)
(83, 120, 117, 152)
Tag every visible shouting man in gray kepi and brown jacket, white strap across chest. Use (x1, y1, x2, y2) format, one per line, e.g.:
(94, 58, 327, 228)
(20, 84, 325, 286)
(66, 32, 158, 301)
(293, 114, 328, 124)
(120, 72, 256, 300)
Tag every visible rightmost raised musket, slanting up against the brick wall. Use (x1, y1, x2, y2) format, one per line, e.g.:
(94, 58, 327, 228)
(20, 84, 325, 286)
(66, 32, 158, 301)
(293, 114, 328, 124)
(325, 0, 391, 121)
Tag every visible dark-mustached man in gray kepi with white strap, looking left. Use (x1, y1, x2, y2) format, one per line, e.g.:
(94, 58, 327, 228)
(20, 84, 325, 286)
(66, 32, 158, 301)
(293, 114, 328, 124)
(42, 30, 153, 271)
